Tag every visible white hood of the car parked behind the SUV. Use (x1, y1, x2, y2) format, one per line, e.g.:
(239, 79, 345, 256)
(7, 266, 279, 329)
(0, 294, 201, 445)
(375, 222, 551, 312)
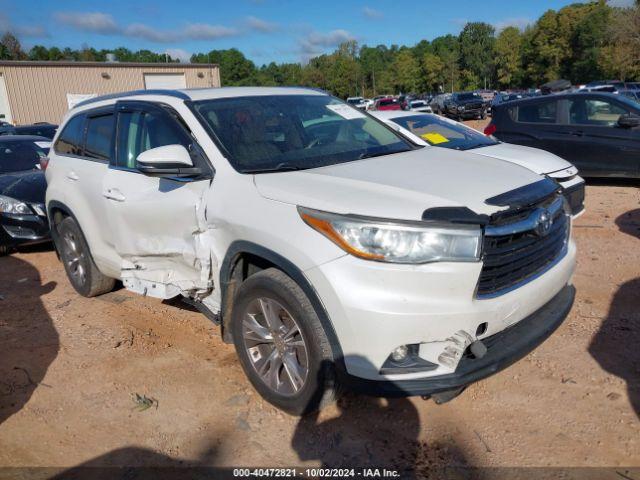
(473, 143, 572, 174)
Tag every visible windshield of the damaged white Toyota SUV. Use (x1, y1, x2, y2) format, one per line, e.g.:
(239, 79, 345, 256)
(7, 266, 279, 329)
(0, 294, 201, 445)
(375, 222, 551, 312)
(194, 95, 412, 173)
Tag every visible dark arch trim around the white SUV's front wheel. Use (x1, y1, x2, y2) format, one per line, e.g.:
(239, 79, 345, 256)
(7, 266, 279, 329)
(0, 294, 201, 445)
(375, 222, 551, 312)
(220, 240, 344, 367)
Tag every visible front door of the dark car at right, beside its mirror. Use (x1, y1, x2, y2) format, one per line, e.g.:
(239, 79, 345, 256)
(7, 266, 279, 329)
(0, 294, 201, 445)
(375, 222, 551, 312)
(562, 94, 640, 177)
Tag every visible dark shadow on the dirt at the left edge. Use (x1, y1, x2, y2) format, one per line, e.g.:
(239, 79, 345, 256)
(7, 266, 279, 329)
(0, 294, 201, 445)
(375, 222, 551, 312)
(0, 256, 60, 424)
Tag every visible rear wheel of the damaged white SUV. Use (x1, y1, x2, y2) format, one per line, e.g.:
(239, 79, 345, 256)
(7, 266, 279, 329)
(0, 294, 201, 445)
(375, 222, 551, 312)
(56, 217, 116, 297)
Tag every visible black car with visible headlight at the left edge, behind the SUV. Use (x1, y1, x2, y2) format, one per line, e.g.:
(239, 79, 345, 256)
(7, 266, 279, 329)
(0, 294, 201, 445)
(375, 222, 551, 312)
(0, 135, 49, 254)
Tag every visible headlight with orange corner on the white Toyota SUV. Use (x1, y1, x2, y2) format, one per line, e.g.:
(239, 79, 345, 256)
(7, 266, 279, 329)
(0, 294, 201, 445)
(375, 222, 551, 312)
(298, 207, 482, 263)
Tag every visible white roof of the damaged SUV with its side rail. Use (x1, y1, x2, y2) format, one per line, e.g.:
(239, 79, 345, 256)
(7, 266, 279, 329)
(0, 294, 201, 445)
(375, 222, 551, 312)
(75, 87, 326, 108)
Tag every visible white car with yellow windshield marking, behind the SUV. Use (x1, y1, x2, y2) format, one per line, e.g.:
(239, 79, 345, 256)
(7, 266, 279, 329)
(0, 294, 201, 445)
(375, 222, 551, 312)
(371, 111, 585, 217)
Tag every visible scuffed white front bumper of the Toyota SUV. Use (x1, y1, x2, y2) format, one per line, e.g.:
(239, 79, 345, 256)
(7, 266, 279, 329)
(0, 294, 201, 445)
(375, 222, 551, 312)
(304, 241, 576, 382)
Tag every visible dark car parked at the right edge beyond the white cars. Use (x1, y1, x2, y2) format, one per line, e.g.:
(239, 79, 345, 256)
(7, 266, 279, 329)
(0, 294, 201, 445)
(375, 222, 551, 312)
(485, 92, 640, 178)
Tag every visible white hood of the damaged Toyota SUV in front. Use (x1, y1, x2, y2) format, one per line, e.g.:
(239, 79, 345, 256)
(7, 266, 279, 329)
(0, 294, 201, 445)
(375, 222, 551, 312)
(254, 148, 541, 220)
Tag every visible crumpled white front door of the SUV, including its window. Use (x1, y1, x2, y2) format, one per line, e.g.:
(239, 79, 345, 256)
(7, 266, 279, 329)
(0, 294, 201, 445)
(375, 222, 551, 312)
(101, 102, 213, 298)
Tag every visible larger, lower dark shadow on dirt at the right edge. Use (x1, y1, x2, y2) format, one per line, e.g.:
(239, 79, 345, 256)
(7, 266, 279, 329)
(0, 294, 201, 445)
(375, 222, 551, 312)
(589, 278, 640, 418)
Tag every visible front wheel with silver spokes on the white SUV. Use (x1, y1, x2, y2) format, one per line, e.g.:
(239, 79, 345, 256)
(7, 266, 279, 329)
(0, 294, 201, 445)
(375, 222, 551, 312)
(231, 268, 338, 415)
